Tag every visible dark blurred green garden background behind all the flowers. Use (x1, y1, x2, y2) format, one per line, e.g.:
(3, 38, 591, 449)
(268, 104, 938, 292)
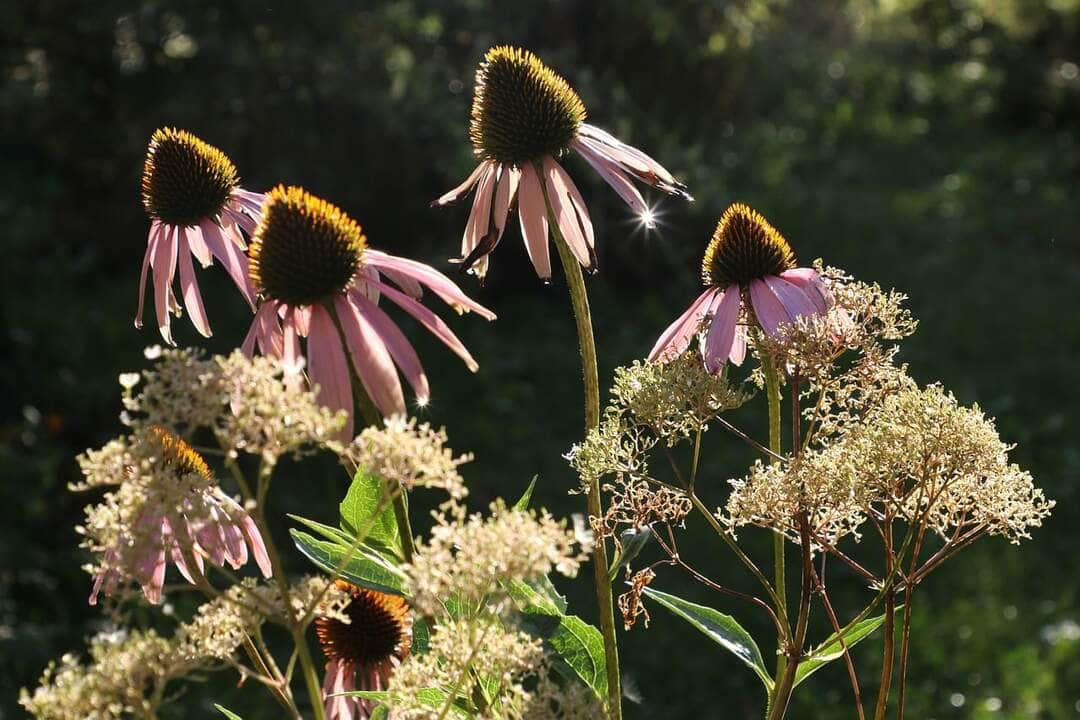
(0, 0, 1080, 720)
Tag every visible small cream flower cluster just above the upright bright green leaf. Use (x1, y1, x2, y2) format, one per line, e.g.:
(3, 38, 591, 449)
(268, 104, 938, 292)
(342, 416, 472, 500)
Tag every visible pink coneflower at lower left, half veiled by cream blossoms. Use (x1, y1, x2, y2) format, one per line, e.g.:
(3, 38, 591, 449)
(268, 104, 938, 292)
(83, 425, 272, 604)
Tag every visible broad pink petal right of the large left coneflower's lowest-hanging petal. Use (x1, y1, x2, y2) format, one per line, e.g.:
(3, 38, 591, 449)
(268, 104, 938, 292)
(334, 293, 406, 417)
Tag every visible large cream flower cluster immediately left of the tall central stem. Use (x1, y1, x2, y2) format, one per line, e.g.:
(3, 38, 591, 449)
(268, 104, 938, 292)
(403, 500, 584, 615)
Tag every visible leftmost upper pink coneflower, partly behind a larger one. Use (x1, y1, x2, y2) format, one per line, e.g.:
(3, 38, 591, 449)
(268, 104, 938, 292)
(135, 127, 262, 344)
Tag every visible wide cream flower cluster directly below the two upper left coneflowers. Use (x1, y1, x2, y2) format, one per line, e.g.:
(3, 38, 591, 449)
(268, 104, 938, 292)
(121, 348, 345, 466)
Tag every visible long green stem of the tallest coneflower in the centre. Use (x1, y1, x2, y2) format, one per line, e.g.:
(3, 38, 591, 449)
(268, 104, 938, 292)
(544, 211, 622, 720)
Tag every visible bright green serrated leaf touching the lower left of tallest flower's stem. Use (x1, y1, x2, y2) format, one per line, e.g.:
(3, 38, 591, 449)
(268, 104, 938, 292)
(522, 612, 607, 697)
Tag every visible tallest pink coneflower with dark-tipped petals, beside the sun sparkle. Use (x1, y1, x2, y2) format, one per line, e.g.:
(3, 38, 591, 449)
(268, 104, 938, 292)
(433, 45, 690, 280)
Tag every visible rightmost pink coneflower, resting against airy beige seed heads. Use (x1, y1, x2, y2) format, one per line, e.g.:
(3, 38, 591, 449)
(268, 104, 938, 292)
(649, 203, 833, 375)
